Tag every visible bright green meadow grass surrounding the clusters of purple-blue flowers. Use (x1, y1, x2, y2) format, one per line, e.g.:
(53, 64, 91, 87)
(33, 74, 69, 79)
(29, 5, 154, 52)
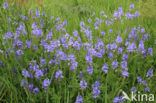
(0, 0, 156, 103)
